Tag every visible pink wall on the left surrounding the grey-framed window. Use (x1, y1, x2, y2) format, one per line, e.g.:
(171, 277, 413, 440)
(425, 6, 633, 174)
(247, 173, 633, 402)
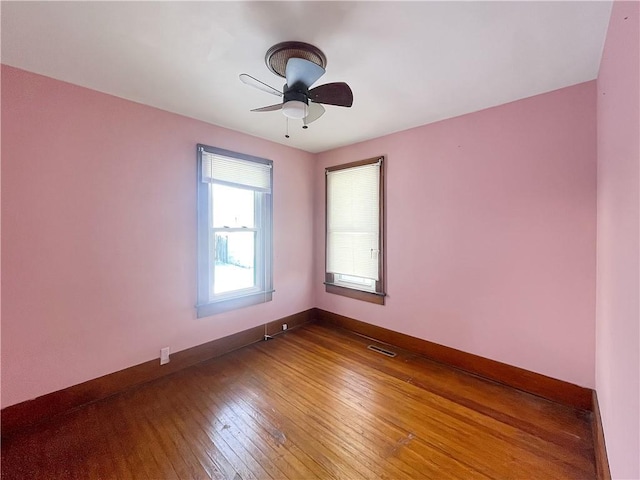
(2, 66, 314, 407)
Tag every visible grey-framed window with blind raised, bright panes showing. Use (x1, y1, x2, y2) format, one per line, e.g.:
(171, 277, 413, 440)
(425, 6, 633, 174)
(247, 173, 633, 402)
(197, 145, 273, 317)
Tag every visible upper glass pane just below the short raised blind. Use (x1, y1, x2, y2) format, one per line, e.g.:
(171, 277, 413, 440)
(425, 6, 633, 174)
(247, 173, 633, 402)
(211, 183, 256, 228)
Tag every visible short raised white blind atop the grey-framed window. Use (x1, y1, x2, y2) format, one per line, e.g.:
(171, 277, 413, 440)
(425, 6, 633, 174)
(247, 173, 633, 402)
(202, 151, 271, 193)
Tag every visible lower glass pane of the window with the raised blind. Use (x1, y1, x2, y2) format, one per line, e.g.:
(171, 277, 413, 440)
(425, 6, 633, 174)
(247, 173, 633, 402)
(213, 231, 256, 295)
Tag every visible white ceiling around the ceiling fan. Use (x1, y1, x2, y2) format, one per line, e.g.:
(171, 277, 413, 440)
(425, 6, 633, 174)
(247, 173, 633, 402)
(0, 1, 611, 152)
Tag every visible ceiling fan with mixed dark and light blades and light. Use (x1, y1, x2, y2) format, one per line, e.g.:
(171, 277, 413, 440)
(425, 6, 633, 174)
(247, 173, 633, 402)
(240, 42, 353, 129)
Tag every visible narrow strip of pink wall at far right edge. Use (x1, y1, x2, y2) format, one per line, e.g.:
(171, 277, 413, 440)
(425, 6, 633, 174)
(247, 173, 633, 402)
(596, 2, 640, 479)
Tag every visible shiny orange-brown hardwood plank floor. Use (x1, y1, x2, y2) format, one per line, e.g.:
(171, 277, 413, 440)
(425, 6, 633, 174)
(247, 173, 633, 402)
(1, 324, 596, 480)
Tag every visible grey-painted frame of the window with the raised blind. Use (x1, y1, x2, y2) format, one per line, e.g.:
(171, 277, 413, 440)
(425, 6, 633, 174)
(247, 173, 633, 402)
(196, 144, 274, 318)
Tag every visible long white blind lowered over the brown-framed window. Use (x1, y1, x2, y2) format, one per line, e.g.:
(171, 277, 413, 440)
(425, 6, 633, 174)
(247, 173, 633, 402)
(327, 162, 380, 280)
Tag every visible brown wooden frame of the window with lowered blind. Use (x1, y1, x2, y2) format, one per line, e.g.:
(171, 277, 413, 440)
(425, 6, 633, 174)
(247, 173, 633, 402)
(324, 155, 387, 305)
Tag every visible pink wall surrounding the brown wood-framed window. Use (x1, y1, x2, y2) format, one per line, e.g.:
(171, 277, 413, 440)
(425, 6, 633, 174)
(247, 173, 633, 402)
(314, 81, 596, 387)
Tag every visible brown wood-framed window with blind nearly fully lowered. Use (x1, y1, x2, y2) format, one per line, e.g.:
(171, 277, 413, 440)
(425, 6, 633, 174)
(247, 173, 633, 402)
(325, 157, 385, 305)
